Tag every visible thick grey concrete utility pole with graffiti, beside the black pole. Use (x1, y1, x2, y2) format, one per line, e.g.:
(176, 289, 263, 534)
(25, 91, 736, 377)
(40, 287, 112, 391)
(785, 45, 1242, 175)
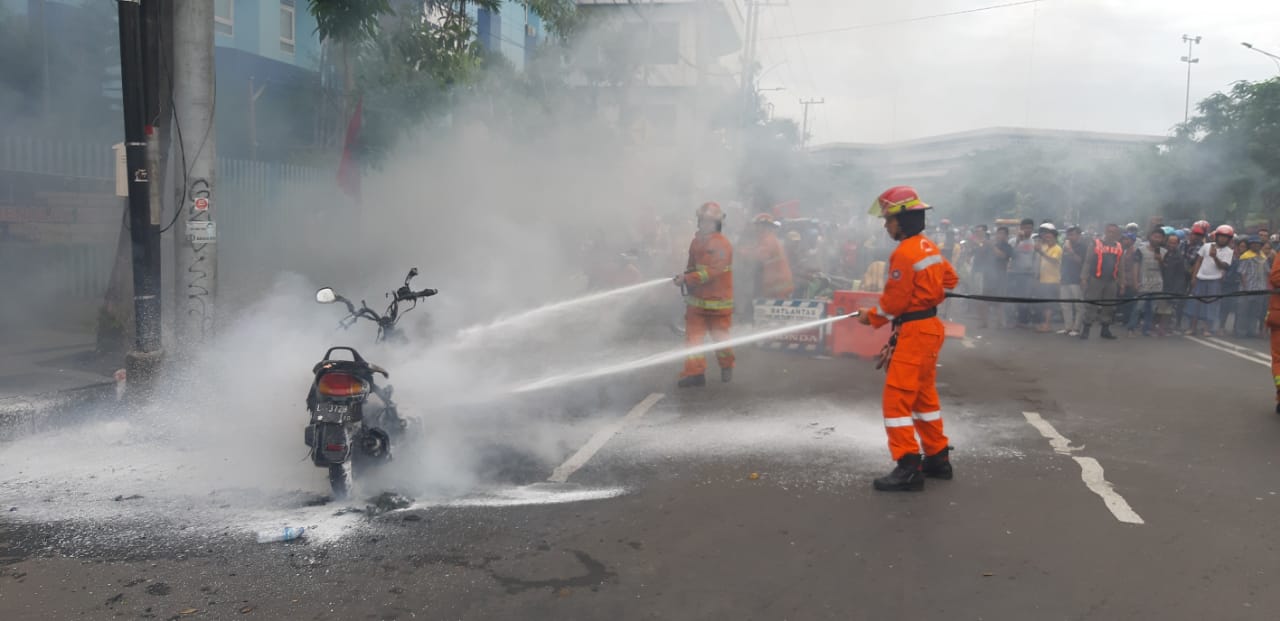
(173, 0, 218, 355)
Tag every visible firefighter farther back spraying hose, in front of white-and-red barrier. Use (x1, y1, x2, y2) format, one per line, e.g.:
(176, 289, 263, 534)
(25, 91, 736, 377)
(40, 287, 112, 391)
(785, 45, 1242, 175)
(672, 202, 733, 388)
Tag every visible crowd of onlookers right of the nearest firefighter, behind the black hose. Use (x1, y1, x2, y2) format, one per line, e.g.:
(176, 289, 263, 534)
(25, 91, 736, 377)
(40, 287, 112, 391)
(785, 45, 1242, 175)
(936, 219, 1280, 338)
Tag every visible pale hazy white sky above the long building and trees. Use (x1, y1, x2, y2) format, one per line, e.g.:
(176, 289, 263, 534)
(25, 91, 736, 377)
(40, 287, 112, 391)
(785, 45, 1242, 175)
(760, 0, 1280, 143)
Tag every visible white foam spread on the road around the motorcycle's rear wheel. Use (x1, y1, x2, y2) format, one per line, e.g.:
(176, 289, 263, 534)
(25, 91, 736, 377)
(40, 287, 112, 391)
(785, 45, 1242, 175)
(0, 420, 626, 543)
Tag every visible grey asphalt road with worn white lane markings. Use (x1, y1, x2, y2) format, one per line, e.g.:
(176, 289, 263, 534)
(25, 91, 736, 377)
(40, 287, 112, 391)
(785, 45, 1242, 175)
(0, 326, 1280, 620)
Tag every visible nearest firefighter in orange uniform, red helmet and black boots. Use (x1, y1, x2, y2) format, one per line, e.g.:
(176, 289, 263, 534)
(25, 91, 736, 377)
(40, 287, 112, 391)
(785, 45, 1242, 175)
(858, 186, 960, 492)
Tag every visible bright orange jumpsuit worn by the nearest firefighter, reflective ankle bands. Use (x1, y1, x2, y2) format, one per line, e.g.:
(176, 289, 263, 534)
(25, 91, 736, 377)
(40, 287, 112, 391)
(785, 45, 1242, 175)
(869, 234, 960, 461)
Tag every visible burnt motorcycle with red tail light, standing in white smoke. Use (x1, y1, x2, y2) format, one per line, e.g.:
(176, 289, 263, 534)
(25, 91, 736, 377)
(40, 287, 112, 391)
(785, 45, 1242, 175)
(303, 268, 438, 499)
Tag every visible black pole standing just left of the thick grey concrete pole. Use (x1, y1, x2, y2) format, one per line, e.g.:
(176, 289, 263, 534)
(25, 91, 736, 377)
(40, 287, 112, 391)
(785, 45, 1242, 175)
(116, 0, 164, 397)
